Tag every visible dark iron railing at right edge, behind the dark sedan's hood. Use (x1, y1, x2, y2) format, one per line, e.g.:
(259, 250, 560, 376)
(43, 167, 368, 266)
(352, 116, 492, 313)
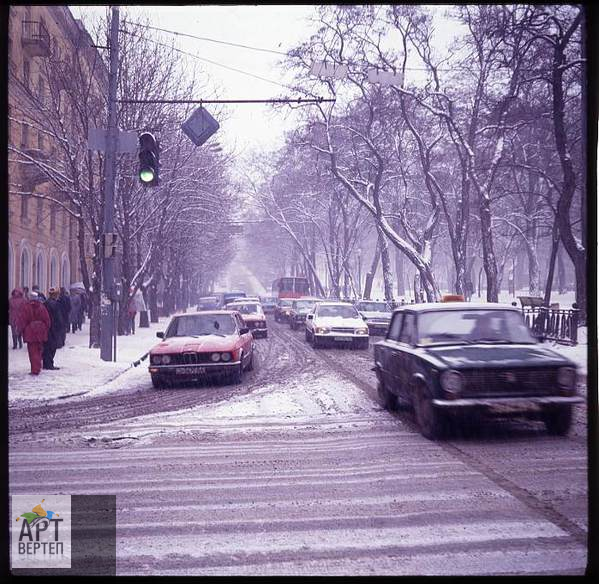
(522, 303, 579, 345)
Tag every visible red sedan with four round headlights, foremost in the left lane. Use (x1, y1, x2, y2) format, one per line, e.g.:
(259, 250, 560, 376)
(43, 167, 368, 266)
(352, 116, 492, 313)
(148, 310, 254, 388)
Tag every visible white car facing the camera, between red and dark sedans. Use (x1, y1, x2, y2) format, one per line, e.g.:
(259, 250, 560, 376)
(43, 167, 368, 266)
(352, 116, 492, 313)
(306, 301, 368, 349)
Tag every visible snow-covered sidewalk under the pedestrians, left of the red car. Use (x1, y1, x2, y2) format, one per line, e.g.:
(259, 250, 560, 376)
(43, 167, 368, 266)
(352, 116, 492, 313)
(8, 317, 170, 402)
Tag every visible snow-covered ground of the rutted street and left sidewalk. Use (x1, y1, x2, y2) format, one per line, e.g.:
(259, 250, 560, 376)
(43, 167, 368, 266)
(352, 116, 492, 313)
(9, 319, 587, 575)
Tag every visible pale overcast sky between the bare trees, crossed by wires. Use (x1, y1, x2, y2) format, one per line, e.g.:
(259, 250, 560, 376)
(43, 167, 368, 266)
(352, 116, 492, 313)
(70, 5, 315, 152)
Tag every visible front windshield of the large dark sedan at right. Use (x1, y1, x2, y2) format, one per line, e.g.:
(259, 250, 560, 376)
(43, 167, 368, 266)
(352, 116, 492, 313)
(418, 310, 536, 345)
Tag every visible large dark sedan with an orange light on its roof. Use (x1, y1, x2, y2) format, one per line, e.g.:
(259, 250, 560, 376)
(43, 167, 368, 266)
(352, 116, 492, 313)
(374, 302, 583, 439)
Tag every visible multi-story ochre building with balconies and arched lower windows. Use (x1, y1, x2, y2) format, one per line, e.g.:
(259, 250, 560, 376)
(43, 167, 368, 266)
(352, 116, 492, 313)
(8, 5, 108, 290)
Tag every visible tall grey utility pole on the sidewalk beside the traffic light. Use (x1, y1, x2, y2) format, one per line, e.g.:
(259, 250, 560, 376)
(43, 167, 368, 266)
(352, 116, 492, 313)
(100, 6, 119, 361)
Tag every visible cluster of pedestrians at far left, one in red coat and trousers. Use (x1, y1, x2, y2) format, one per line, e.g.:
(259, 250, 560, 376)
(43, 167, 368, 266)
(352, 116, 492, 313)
(9, 286, 87, 375)
